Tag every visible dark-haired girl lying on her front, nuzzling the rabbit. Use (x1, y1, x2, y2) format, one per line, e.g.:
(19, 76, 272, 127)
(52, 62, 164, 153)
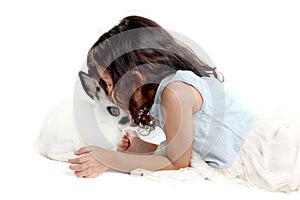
(69, 16, 300, 190)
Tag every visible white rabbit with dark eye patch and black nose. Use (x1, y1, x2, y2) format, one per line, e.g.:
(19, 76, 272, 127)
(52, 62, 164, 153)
(38, 72, 166, 161)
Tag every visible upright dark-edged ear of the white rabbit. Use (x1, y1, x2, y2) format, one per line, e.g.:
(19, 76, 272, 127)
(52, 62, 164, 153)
(79, 71, 101, 100)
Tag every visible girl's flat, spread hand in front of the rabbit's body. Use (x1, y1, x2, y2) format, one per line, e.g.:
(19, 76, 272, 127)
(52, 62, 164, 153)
(68, 146, 109, 178)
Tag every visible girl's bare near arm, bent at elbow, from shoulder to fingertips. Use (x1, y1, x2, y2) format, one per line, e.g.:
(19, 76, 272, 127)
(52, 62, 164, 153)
(69, 82, 202, 177)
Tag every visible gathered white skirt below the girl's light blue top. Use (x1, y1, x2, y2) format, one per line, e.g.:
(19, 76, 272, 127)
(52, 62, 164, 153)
(220, 107, 300, 192)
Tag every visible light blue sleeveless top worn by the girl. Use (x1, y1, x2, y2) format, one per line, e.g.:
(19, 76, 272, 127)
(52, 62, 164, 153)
(150, 70, 254, 168)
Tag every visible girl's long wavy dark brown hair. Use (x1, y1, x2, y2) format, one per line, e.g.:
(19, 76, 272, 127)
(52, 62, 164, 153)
(87, 16, 223, 124)
